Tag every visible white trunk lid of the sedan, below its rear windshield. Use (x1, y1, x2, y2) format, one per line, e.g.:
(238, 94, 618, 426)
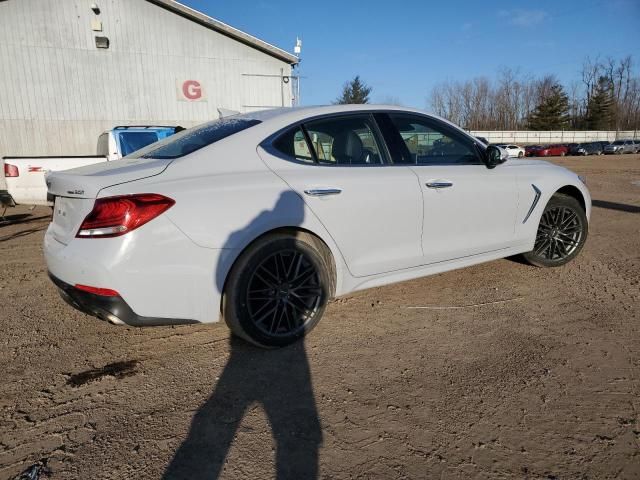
(46, 158, 172, 245)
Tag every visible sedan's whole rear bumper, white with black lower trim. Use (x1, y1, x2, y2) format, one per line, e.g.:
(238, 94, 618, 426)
(43, 216, 231, 326)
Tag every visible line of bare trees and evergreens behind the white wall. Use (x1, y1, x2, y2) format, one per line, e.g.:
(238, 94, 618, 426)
(429, 56, 640, 130)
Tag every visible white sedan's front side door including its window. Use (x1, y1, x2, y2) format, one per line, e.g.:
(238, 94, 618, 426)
(380, 113, 518, 264)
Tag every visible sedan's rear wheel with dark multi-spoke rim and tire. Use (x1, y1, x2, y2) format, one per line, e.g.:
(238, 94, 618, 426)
(222, 232, 333, 348)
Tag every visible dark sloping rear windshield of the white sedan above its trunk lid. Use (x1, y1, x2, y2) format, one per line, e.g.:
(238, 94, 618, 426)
(129, 117, 260, 159)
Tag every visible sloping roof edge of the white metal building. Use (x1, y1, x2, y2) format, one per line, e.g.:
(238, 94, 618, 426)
(147, 0, 300, 65)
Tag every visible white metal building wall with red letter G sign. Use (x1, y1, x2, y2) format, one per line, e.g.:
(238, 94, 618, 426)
(0, 0, 298, 156)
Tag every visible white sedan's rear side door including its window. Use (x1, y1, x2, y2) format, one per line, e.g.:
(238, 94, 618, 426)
(259, 114, 423, 277)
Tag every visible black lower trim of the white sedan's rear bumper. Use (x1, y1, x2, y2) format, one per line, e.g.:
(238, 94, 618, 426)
(49, 272, 199, 327)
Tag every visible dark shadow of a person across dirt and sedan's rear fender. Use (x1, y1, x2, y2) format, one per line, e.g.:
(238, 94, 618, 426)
(164, 191, 322, 480)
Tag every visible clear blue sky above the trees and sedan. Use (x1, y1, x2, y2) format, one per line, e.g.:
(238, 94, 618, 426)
(182, 0, 640, 108)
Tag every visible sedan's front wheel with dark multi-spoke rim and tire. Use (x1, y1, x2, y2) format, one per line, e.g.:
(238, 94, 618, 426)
(523, 193, 589, 267)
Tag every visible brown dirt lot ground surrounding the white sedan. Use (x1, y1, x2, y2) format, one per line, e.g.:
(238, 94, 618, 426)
(0, 155, 640, 479)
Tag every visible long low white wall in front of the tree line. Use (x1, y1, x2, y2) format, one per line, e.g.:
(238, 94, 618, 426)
(471, 130, 640, 145)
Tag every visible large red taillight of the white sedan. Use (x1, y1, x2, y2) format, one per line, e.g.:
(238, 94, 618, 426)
(76, 193, 176, 238)
